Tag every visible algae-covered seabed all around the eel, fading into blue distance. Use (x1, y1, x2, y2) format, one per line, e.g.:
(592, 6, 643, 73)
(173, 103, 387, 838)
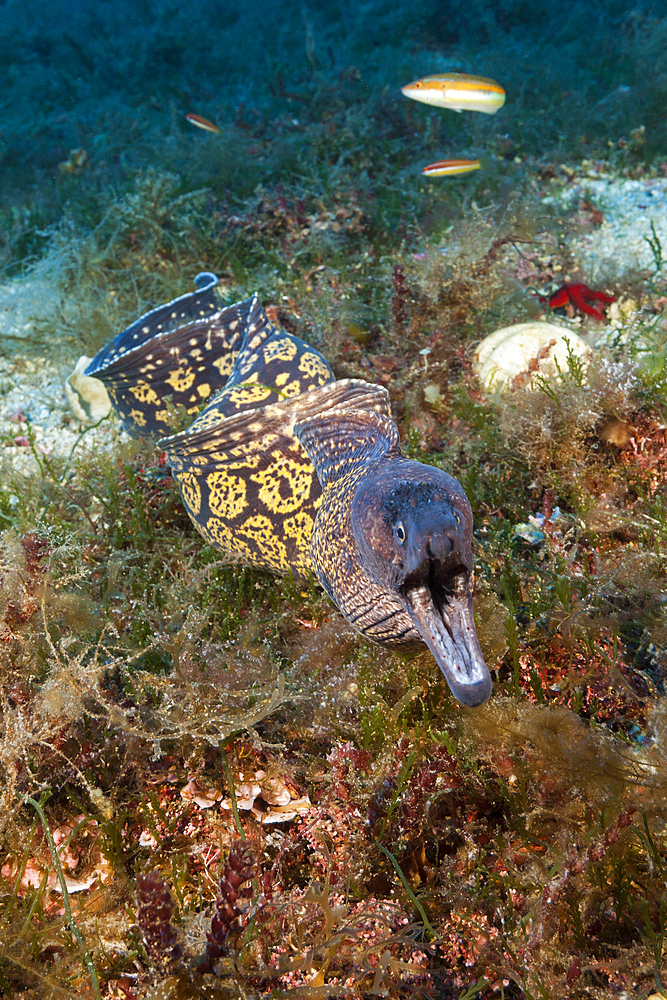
(0, 2, 667, 1000)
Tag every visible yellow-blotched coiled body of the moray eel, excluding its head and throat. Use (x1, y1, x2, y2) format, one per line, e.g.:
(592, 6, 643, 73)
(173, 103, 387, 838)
(96, 282, 400, 577)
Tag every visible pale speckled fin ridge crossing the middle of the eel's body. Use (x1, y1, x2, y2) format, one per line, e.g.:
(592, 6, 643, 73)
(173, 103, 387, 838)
(159, 379, 389, 474)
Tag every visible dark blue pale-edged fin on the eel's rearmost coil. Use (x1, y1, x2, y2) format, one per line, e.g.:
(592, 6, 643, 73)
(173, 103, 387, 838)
(86, 271, 223, 376)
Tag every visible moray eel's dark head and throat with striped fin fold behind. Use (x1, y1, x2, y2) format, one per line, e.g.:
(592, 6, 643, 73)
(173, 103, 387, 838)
(294, 382, 492, 706)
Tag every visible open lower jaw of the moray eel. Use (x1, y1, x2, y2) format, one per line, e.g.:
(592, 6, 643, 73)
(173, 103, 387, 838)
(403, 578, 493, 708)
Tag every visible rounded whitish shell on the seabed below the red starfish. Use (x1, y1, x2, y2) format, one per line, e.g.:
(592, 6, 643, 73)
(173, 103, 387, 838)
(473, 322, 593, 392)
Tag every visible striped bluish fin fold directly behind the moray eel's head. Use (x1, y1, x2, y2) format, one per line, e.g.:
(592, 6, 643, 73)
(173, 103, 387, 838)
(294, 404, 401, 489)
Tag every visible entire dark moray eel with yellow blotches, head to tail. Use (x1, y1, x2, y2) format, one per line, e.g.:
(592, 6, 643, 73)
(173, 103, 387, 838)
(86, 274, 492, 706)
